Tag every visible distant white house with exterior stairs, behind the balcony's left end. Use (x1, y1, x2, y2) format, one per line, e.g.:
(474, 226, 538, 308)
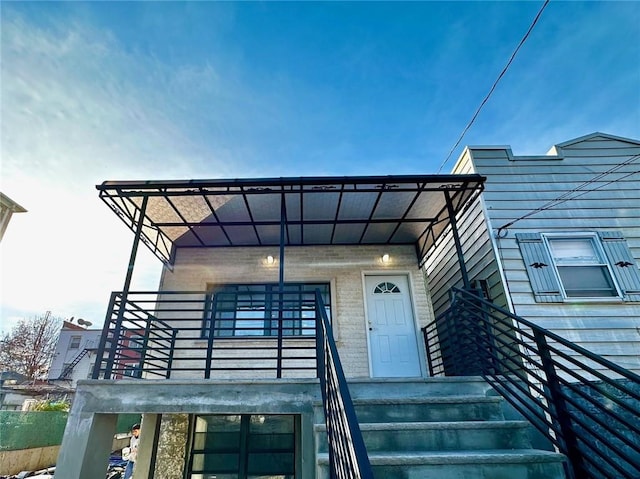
(49, 318, 102, 388)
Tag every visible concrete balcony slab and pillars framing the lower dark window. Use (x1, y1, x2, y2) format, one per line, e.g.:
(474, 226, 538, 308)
(56, 379, 321, 479)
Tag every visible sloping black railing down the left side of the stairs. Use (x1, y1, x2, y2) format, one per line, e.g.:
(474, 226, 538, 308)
(316, 291, 373, 479)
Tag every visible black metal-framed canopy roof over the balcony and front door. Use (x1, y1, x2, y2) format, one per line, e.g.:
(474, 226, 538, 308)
(96, 174, 485, 272)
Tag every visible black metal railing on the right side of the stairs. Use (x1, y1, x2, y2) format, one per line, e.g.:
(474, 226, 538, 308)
(423, 289, 640, 479)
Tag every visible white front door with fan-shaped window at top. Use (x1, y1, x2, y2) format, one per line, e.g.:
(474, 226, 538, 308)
(365, 275, 421, 378)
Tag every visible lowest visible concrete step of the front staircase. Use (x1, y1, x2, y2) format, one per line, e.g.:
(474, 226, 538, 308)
(316, 449, 566, 479)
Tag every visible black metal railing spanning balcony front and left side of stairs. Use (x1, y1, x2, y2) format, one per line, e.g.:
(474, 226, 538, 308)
(93, 289, 373, 479)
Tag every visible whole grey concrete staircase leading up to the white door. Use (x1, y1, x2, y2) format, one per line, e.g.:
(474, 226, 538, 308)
(314, 378, 565, 479)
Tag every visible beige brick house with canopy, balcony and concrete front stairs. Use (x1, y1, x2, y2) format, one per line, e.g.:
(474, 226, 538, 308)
(56, 140, 637, 479)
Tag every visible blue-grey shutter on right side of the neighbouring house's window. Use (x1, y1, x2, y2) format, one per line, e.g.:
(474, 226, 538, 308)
(598, 231, 640, 301)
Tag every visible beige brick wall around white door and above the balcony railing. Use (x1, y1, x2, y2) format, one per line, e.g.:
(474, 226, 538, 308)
(161, 246, 432, 378)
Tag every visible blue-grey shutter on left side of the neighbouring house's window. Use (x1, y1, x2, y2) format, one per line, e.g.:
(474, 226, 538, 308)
(516, 233, 564, 303)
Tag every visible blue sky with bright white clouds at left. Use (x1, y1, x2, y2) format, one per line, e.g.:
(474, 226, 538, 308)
(0, 1, 640, 330)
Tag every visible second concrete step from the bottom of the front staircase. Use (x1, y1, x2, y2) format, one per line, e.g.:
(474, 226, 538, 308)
(314, 421, 531, 453)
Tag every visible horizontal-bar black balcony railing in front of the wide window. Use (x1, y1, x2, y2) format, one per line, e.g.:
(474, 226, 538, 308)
(93, 289, 328, 379)
